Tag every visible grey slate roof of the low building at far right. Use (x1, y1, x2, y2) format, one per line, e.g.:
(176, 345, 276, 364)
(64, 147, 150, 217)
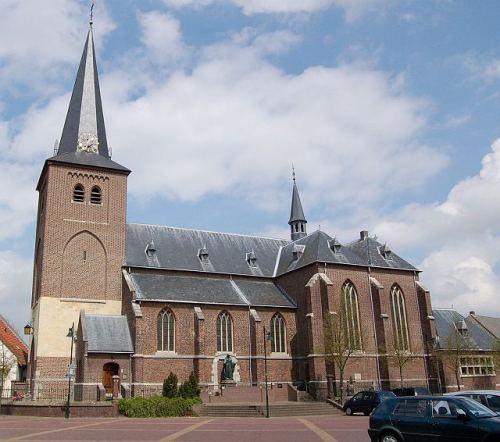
(432, 309, 494, 350)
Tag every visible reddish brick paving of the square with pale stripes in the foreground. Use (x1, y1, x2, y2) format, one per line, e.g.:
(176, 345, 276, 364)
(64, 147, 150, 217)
(0, 416, 370, 442)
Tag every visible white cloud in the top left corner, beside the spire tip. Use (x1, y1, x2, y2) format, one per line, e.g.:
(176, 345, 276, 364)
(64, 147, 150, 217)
(0, 0, 114, 95)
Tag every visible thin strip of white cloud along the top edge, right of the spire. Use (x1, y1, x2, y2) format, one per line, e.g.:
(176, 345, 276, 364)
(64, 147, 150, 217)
(163, 0, 388, 22)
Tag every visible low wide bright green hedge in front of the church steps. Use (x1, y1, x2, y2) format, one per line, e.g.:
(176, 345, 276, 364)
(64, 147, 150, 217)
(118, 396, 199, 417)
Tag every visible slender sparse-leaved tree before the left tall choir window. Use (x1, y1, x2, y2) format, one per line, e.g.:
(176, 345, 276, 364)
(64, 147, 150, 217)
(323, 306, 361, 402)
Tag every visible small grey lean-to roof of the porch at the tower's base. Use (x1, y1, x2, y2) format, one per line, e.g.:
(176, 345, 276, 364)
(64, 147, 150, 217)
(84, 314, 134, 353)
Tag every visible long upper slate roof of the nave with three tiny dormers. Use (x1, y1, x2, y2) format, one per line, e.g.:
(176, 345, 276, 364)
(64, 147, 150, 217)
(126, 224, 289, 277)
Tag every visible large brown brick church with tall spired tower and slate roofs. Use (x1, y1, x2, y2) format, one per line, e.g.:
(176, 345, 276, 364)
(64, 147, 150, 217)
(29, 22, 435, 399)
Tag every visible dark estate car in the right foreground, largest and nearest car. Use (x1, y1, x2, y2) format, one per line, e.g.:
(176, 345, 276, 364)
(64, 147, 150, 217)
(368, 396, 500, 442)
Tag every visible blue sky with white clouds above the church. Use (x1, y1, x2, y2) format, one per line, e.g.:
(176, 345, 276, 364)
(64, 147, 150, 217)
(0, 0, 500, 330)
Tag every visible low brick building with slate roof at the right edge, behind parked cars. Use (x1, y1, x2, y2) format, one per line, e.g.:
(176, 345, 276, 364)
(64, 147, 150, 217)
(432, 309, 500, 391)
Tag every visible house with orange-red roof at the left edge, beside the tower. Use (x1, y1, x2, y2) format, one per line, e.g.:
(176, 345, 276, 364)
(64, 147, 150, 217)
(0, 315, 28, 397)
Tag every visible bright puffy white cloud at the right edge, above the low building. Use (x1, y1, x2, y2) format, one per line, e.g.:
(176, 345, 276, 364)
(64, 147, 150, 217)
(375, 139, 500, 314)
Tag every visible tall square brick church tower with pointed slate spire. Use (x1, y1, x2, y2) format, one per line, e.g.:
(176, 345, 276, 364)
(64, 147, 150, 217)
(30, 22, 130, 391)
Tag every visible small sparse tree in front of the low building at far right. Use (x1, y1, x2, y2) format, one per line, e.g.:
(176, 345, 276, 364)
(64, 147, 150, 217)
(435, 328, 473, 391)
